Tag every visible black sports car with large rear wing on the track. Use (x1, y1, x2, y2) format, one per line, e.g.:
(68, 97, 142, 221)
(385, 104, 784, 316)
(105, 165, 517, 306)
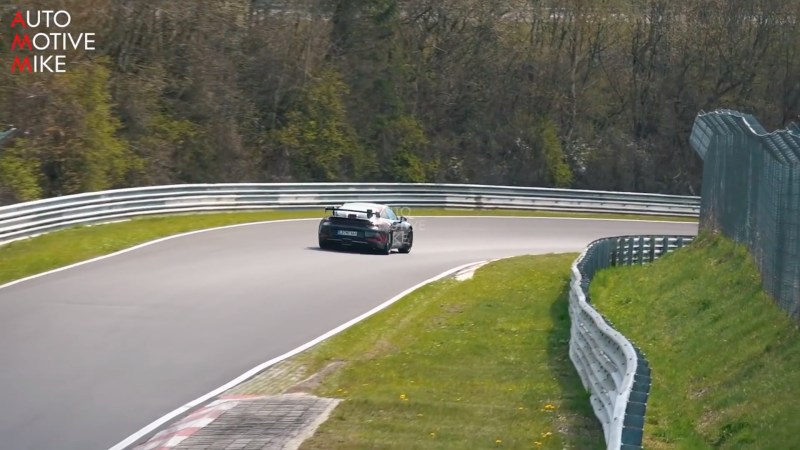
(319, 203, 414, 255)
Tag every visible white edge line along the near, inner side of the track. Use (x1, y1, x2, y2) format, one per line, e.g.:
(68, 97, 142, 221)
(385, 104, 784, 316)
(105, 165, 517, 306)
(109, 261, 485, 450)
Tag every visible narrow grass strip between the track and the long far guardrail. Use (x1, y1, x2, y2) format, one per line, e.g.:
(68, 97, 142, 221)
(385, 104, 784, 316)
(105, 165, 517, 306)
(0, 209, 685, 284)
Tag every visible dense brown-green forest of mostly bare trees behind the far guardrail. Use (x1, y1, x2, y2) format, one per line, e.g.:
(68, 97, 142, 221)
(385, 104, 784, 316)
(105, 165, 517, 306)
(0, 0, 800, 203)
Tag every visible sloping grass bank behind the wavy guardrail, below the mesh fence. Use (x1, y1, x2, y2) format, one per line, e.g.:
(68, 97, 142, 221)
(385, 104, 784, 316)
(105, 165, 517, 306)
(590, 235, 800, 449)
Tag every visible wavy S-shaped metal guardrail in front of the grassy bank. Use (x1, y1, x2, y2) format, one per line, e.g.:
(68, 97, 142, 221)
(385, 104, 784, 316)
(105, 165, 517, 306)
(569, 236, 694, 450)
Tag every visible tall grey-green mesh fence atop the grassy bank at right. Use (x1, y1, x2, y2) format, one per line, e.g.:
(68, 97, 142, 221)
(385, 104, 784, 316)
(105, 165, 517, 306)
(690, 110, 800, 320)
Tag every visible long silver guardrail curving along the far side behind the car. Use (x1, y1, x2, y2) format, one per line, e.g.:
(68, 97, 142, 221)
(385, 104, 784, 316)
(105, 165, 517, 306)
(0, 183, 700, 244)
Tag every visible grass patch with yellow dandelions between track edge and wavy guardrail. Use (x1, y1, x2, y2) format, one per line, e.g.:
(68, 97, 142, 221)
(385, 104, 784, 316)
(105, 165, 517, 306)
(238, 254, 604, 450)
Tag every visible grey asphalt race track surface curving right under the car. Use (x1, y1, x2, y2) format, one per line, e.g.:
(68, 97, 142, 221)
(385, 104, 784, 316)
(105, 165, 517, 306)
(0, 217, 697, 450)
